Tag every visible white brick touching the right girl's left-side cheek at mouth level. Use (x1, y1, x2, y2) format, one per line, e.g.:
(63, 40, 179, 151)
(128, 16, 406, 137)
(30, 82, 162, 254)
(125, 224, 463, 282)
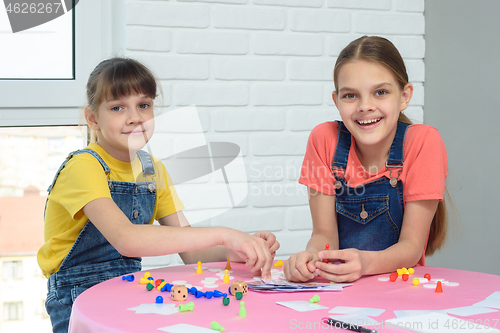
(287, 107, 339, 132)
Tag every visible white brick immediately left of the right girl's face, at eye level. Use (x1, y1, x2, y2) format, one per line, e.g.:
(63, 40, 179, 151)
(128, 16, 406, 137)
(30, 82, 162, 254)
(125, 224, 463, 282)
(253, 83, 323, 106)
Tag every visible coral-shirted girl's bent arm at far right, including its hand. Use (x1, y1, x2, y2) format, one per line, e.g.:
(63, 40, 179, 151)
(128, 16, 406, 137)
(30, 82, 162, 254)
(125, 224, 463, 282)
(316, 200, 439, 282)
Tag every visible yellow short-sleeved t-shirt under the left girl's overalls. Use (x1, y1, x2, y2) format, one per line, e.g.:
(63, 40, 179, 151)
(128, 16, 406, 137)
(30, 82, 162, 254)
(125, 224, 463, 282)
(37, 144, 184, 278)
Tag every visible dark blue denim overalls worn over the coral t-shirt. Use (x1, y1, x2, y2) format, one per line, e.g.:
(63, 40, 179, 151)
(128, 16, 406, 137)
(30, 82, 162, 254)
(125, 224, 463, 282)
(332, 121, 408, 251)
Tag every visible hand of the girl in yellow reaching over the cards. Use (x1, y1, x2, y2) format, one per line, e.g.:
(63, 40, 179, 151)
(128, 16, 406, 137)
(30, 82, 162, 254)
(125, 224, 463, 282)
(222, 228, 279, 279)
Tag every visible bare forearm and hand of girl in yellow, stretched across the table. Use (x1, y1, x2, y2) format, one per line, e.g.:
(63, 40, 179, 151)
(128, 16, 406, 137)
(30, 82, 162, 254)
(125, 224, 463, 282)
(83, 198, 279, 277)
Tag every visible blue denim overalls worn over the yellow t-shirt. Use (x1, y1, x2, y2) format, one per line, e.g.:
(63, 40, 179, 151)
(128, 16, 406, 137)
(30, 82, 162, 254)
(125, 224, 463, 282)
(45, 149, 156, 333)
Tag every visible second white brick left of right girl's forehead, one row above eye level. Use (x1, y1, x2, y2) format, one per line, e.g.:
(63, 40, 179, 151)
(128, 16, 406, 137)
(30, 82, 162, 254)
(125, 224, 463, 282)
(213, 57, 286, 81)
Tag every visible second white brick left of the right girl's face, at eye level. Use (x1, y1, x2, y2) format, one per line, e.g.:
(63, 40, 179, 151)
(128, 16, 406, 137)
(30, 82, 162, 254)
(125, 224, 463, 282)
(174, 83, 249, 106)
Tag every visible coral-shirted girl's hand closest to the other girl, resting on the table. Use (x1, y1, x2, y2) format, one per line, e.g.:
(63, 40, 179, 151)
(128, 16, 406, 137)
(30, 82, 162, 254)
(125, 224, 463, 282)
(283, 251, 320, 282)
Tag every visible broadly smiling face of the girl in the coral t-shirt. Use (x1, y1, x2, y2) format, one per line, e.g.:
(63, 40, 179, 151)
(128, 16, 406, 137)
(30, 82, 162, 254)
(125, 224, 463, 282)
(332, 60, 413, 163)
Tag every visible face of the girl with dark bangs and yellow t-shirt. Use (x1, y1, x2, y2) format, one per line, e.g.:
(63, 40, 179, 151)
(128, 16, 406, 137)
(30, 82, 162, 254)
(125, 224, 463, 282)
(85, 94, 154, 161)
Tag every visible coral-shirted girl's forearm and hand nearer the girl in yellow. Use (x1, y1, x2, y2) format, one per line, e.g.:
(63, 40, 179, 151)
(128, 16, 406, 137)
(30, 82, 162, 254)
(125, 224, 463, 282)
(283, 187, 339, 282)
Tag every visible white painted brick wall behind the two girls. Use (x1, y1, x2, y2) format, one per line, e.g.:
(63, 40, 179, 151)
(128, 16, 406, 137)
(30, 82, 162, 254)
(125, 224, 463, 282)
(126, 0, 425, 268)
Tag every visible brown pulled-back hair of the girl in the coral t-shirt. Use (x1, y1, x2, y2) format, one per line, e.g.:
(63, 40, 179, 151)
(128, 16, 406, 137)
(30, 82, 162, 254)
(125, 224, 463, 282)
(333, 36, 449, 256)
